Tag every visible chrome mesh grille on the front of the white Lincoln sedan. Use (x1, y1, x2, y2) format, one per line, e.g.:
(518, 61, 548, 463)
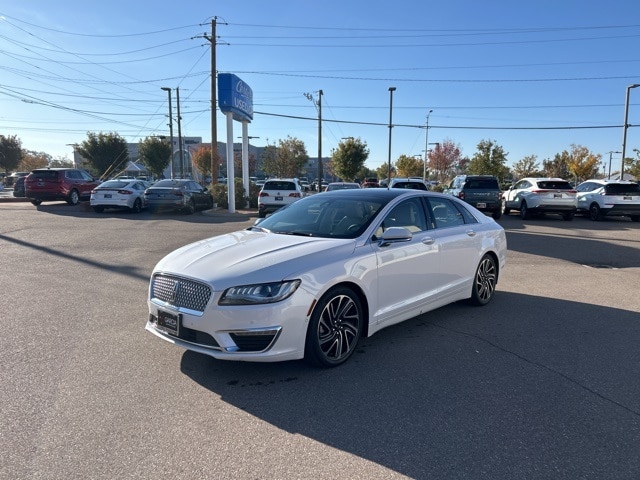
(151, 274, 211, 312)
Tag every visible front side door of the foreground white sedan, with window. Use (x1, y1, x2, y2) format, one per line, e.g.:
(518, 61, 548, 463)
(372, 197, 441, 325)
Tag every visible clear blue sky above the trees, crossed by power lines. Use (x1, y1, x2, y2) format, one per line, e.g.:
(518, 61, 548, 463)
(0, 0, 640, 172)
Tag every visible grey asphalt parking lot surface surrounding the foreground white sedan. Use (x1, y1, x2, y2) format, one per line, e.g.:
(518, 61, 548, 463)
(0, 202, 640, 479)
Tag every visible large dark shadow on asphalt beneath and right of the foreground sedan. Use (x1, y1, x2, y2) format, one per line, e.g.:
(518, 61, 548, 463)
(181, 292, 640, 478)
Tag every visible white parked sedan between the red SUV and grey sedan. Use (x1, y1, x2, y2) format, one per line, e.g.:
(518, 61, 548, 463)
(89, 179, 148, 213)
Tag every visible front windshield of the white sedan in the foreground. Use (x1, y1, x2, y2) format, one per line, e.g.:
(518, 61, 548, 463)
(258, 195, 389, 238)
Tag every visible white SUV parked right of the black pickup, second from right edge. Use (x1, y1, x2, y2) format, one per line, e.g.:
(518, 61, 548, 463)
(502, 178, 578, 220)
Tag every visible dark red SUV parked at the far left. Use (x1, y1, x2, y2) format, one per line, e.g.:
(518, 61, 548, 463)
(24, 168, 100, 205)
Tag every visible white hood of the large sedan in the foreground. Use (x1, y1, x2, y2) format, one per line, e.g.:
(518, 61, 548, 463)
(154, 230, 355, 291)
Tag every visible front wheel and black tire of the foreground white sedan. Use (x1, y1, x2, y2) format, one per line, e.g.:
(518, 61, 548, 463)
(305, 287, 364, 367)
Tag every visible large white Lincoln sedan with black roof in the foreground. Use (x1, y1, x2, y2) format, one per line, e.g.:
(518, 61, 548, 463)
(146, 188, 507, 367)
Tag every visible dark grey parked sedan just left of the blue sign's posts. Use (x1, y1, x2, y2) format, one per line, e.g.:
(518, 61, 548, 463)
(144, 179, 213, 213)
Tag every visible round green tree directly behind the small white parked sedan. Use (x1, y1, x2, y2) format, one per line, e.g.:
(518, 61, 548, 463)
(76, 132, 129, 177)
